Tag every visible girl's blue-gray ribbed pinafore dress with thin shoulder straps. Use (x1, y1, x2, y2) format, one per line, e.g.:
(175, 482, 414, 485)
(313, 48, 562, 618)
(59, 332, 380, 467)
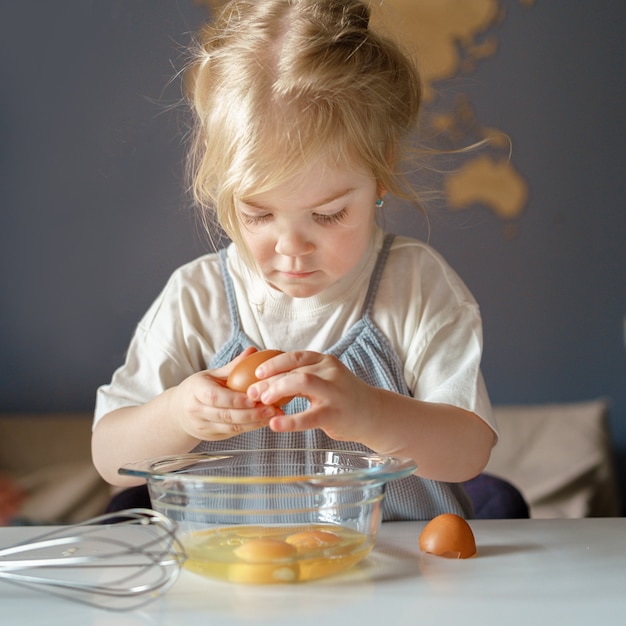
(194, 234, 472, 521)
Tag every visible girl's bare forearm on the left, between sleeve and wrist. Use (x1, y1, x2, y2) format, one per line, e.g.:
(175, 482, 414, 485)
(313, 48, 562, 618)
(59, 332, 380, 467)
(91, 390, 198, 486)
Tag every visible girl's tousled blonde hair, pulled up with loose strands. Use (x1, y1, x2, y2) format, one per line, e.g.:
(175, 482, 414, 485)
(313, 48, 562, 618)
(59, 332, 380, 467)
(186, 0, 421, 245)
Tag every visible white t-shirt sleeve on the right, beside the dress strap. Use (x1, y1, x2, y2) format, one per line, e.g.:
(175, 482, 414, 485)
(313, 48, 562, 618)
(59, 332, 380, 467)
(388, 238, 497, 434)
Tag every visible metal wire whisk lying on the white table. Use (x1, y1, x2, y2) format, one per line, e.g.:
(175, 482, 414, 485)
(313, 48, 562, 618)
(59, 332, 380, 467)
(0, 509, 186, 610)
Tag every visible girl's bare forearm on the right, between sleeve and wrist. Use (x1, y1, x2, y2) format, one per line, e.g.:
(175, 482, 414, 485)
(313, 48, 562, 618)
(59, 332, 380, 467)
(362, 389, 494, 482)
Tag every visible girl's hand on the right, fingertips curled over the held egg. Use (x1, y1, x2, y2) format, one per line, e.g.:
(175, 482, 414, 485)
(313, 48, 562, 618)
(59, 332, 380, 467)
(248, 351, 380, 441)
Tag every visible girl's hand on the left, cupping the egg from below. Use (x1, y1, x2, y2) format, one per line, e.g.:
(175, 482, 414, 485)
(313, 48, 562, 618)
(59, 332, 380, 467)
(171, 348, 282, 441)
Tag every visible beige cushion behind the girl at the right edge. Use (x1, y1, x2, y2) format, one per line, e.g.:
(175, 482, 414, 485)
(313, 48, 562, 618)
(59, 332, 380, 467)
(485, 399, 621, 518)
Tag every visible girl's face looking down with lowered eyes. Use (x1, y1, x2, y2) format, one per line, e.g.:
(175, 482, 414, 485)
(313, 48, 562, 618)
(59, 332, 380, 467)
(235, 162, 378, 298)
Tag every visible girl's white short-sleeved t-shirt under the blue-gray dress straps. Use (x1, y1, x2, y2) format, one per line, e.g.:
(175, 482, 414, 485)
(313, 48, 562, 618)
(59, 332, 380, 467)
(94, 230, 495, 431)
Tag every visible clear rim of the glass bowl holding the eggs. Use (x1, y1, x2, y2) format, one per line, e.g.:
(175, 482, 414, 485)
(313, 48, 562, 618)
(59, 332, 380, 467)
(118, 448, 417, 485)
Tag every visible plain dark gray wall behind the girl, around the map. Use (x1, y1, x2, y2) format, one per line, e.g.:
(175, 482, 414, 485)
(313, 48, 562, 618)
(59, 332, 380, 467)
(0, 0, 626, 508)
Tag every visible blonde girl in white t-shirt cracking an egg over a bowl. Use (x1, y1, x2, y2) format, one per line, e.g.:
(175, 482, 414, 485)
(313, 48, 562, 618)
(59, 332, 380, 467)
(93, 0, 495, 520)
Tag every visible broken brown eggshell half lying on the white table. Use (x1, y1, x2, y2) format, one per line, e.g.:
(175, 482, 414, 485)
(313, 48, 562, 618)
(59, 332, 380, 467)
(419, 513, 476, 559)
